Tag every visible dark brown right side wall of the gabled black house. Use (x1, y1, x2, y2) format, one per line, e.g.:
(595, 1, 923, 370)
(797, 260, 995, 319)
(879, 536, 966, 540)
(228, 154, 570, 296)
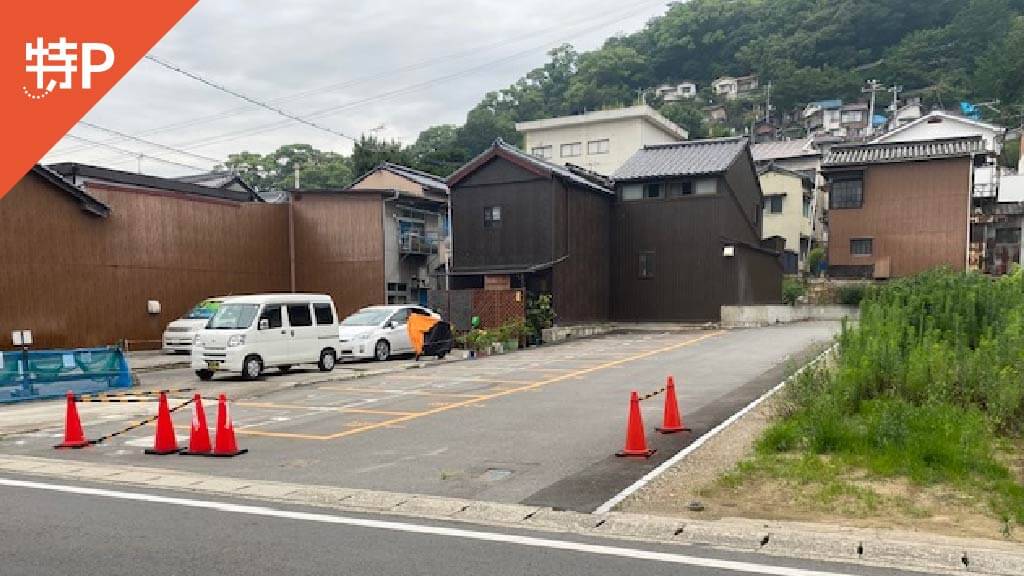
(552, 181, 613, 322)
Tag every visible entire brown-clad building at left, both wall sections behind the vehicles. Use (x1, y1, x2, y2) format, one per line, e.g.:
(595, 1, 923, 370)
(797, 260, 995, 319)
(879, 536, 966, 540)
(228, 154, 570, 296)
(0, 164, 384, 347)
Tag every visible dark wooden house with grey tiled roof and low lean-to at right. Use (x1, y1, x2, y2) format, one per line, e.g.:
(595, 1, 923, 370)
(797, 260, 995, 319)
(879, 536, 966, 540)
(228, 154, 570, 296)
(611, 138, 782, 322)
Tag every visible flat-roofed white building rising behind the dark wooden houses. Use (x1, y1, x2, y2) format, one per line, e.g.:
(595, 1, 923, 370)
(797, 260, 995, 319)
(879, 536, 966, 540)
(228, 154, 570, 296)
(515, 106, 689, 175)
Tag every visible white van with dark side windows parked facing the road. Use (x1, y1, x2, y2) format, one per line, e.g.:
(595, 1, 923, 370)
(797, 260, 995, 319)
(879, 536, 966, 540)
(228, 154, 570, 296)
(191, 294, 340, 380)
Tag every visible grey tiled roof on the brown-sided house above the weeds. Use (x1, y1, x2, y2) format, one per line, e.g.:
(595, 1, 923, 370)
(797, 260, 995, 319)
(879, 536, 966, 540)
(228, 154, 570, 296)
(823, 136, 985, 167)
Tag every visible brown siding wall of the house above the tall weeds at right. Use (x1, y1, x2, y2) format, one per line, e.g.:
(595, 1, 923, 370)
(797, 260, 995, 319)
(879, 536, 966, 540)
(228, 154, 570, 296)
(828, 158, 971, 277)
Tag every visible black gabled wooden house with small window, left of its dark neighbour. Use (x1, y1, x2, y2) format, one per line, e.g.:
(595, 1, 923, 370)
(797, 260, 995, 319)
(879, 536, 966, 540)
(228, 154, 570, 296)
(449, 139, 614, 322)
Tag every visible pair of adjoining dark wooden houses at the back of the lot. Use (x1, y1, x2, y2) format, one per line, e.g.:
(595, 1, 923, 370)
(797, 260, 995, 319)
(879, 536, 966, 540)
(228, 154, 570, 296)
(449, 138, 781, 323)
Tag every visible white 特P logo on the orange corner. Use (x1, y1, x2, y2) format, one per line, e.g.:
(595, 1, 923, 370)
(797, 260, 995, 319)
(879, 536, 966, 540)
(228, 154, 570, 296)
(22, 36, 114, 100)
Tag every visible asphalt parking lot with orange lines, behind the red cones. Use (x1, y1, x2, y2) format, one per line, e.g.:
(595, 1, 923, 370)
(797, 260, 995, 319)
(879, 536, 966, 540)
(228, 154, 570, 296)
(0, 323, 838, 509)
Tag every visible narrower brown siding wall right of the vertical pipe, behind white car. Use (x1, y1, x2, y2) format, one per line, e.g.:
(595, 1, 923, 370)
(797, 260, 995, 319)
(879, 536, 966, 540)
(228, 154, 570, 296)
(295, 194, 386, 318)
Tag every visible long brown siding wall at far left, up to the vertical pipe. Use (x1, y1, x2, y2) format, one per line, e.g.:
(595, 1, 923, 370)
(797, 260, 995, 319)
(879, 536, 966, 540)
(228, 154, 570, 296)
(0, 173, 289, 347)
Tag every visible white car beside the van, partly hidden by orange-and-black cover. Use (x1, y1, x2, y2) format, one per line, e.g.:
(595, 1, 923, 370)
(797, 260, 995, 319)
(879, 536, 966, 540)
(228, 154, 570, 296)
(338, 304, 440, 361)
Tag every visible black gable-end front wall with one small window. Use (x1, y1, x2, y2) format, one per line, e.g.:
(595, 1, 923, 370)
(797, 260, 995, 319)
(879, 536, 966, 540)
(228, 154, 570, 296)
(451, 158, 557, 272)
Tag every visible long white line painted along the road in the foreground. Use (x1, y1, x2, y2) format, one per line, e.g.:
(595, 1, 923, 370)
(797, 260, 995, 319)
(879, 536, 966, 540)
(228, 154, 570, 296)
(0, 478, 853, 576)
